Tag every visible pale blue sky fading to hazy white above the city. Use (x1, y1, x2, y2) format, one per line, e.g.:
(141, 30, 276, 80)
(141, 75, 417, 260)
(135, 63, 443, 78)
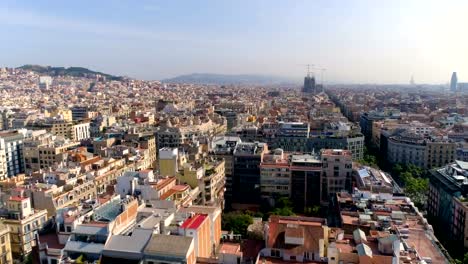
(0, 0, 468, 84)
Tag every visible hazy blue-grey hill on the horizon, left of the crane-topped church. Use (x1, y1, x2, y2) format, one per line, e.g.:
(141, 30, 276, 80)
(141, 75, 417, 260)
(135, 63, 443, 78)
(162, 73, 294, 85)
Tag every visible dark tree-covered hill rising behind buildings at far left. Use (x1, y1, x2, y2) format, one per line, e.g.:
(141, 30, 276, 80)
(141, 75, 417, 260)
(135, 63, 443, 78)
(18, 64, 122, 80)
